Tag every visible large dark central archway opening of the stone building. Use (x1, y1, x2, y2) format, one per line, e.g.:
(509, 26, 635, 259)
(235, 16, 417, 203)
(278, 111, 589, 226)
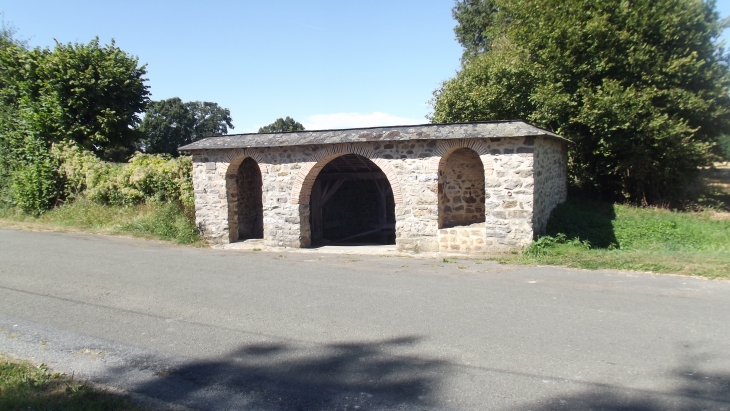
(309, 154, 395, 245)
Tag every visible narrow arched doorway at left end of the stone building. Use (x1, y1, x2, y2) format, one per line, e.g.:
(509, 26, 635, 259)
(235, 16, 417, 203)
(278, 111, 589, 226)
(227, 157, 264, 242)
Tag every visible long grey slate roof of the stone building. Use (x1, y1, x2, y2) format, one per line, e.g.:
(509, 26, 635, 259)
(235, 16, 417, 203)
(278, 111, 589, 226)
(178, 120, 572, 151)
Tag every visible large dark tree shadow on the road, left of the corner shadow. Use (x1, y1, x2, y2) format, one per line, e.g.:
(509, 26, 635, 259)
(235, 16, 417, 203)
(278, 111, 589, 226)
(115, 337, 447, 410)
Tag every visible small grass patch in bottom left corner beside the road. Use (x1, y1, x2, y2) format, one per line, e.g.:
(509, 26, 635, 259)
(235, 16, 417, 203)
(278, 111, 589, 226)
(0, 356, 143, 411)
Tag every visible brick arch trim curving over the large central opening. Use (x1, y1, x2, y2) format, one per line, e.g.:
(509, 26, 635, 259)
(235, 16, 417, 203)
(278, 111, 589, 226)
(291, 144, 403, 204)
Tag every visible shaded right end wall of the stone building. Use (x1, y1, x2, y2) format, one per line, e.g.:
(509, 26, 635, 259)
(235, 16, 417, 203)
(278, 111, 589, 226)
(532, 139, 568, 234)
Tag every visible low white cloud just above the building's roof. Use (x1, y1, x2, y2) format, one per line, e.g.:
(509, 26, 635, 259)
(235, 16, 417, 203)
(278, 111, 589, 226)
(302, 111, 428, 130)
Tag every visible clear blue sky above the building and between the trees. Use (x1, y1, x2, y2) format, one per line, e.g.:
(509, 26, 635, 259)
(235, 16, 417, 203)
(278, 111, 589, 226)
(0, 0, 730, 133)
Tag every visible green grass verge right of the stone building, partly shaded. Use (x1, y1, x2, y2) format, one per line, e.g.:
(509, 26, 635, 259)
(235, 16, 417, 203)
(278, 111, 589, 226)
(495, 199, 730, 279)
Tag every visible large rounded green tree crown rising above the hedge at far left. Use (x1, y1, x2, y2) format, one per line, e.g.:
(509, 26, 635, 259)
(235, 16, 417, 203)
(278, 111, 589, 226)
(0, 38, 149, 161)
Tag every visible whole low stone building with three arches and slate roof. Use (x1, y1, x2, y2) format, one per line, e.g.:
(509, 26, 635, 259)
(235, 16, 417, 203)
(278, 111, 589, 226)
(180, 121, 570, 253)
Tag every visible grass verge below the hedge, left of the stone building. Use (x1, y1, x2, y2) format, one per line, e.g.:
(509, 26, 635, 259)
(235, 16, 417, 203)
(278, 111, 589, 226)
(0, 198, 202, 245)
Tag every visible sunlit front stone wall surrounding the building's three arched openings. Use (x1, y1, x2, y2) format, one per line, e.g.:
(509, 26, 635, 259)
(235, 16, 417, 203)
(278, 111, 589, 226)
(188, 137, 564, 251)
